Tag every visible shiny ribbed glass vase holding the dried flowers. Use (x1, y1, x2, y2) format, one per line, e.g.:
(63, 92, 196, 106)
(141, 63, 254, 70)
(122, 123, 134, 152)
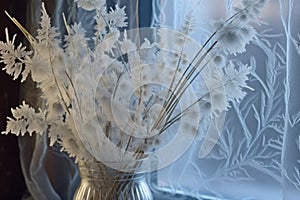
(73, 161, 153, 200)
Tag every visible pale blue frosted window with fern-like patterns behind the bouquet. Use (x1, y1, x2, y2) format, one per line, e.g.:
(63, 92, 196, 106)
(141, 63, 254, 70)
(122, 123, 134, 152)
(152, 0, 300, 200)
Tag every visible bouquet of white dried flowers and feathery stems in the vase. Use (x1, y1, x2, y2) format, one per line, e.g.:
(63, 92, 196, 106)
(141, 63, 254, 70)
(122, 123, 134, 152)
(0, 0, 266, 166)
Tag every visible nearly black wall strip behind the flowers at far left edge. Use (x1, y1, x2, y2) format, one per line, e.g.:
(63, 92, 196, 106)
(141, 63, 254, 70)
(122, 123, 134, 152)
(0, 0, 27, 200)
